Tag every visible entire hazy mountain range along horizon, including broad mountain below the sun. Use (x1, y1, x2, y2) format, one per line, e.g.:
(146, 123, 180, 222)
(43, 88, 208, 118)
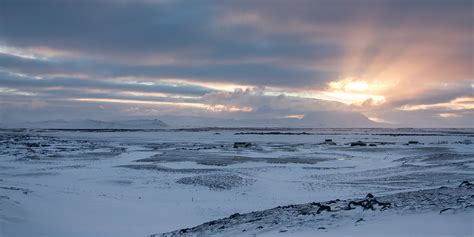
(0, 111, 384, 129)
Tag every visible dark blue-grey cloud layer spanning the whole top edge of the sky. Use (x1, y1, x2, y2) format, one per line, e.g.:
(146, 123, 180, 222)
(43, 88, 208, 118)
(0, 0, 473, 62)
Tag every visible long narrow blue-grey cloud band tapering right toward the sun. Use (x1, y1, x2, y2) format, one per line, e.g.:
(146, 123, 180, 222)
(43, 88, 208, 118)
(0, 54, 335, 88)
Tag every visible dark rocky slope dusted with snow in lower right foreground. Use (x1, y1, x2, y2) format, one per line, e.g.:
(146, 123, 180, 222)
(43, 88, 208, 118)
(151, 181, 474, 237)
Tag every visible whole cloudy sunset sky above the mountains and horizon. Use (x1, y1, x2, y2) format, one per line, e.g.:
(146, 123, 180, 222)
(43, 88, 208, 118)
(0, 0, 474, 127)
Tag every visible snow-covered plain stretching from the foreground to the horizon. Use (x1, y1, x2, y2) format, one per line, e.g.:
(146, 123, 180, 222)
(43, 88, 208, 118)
(0, 129, 474, 237)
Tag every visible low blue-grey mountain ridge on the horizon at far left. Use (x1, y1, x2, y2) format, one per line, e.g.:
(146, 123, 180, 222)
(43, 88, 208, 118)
(0, 119, 168, 129)
